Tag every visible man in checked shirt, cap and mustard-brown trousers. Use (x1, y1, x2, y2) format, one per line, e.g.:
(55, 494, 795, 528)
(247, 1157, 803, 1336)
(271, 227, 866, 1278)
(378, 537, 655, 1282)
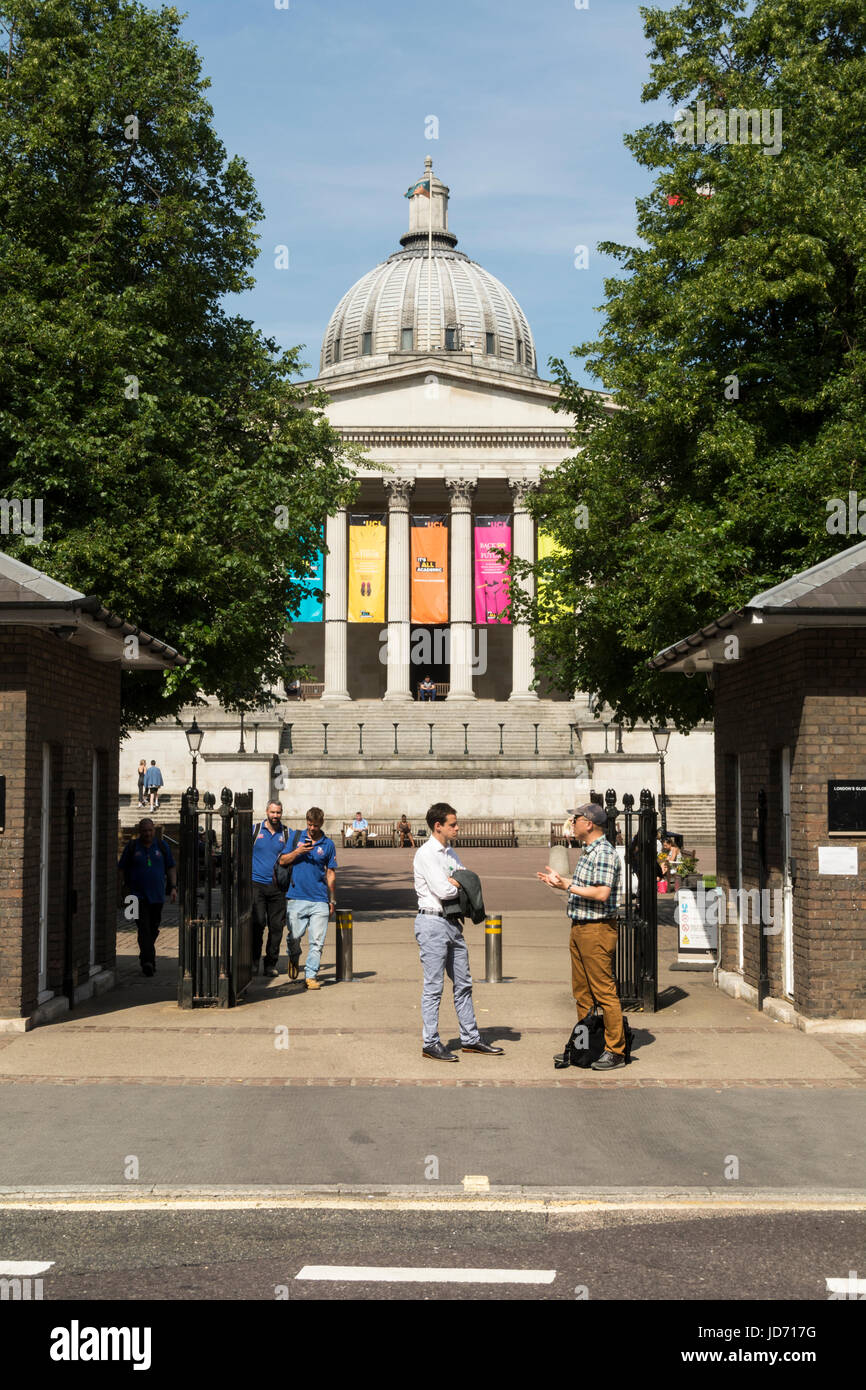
(538, 802, 626, 1072)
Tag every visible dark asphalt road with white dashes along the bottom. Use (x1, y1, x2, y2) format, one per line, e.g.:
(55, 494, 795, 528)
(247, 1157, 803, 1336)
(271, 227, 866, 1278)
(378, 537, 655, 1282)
(0, 1208, 866, 1301)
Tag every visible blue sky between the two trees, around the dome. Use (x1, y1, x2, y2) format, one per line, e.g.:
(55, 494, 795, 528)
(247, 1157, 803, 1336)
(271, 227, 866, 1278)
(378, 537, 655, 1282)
(143, 0, 670, 384)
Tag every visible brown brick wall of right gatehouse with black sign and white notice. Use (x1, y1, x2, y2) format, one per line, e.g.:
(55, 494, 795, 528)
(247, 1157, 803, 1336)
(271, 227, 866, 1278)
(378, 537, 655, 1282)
(714, 628, 866, 1017)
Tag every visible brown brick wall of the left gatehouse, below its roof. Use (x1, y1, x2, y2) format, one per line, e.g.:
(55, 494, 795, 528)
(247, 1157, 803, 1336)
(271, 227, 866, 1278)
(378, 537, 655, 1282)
(0, 627, 120, 1017)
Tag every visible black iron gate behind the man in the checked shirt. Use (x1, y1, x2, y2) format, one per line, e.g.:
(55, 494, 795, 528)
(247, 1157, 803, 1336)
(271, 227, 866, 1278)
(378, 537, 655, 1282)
(591, 788, 659, 1013)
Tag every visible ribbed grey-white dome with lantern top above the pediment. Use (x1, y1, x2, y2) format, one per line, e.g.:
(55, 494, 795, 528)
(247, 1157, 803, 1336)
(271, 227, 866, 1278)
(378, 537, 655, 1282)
(320, 156, 538, 377)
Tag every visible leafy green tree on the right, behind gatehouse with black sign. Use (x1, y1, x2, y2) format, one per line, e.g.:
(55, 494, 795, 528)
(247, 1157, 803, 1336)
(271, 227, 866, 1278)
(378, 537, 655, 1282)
(516, 0, 866, 730)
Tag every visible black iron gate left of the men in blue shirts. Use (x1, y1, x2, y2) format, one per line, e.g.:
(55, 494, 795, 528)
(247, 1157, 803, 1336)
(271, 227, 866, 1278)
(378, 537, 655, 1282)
(178, 787, 253, 1009)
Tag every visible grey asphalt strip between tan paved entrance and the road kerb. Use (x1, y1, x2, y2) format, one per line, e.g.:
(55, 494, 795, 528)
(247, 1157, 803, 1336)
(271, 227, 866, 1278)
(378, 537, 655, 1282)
(0, 1078, 866, 1193)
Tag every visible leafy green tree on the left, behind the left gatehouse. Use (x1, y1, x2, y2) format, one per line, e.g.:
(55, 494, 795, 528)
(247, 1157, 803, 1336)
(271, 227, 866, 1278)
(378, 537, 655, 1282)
(0, 0, 353, 726)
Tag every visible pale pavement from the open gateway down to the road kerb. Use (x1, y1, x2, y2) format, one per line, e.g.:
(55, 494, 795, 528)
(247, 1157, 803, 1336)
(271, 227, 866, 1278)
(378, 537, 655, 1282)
(0, 849, 866, 1195)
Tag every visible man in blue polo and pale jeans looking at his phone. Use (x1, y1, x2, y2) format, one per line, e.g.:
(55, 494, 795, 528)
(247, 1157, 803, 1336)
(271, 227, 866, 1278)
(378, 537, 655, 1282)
(279, 806, 338, 990)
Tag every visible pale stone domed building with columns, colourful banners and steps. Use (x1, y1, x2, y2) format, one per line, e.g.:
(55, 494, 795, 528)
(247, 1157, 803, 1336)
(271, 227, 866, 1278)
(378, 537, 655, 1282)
(124, 157, 713, 845)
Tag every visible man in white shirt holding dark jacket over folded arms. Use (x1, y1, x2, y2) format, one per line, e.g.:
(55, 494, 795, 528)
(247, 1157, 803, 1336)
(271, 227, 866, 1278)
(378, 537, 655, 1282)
(413, 801, 505, 1062)
